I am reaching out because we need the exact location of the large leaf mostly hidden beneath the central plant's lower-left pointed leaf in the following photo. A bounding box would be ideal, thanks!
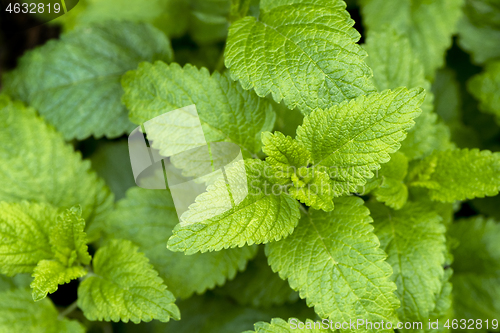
[106,187,256,298]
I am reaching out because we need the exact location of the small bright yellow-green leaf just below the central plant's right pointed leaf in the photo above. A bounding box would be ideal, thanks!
[373,152,408,209]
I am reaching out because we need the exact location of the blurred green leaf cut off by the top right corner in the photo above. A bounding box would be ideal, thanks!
[457,0,500,64]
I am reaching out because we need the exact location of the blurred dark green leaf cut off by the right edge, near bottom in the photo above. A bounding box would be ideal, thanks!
[449,216,500,332]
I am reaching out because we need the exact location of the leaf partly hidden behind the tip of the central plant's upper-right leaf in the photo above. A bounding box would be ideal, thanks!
[365,29,450,159]
